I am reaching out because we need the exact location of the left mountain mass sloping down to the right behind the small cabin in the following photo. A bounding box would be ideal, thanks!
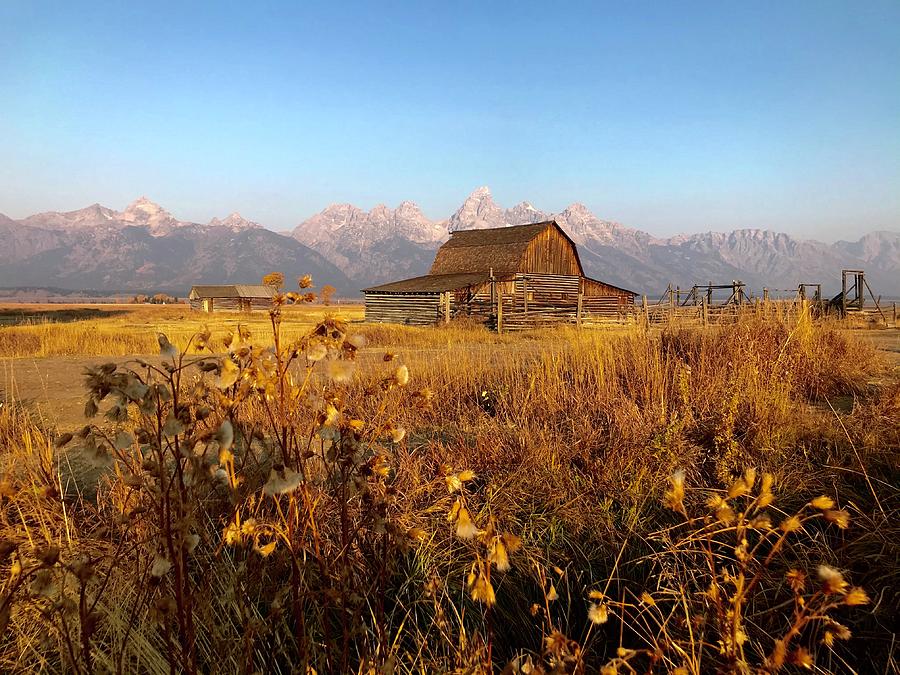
[0,197,355,294]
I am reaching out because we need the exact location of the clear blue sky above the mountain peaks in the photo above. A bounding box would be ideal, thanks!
[0,0,900,240]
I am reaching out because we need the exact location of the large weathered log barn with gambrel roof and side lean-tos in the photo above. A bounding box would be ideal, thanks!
[363,221,635,330]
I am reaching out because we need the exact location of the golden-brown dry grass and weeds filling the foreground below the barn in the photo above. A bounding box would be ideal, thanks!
[0,297,900,673]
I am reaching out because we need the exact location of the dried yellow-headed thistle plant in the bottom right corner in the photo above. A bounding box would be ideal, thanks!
[591,468,868,673]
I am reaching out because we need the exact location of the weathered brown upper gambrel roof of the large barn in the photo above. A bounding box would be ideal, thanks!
[430,220,583,276]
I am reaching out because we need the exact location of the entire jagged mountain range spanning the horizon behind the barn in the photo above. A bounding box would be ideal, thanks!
[0,187,900,296]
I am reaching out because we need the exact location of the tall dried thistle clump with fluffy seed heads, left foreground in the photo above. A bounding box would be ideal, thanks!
[27,277,429,673]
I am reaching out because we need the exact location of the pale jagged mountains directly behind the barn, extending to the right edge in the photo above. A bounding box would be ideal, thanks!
[293,187,900,296]
